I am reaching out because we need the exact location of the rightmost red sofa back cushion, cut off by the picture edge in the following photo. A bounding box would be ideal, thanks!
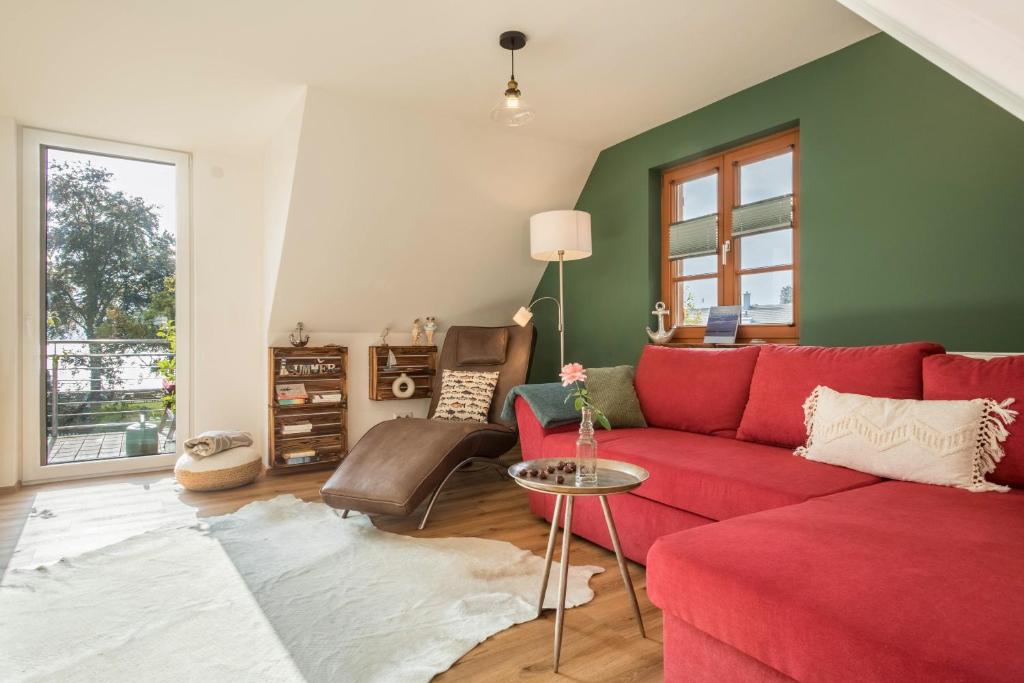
[924,354,1024,487]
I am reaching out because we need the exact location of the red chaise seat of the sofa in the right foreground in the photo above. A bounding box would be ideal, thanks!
[647,481,1024,682]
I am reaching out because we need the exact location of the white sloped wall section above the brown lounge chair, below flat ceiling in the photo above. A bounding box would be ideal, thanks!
[268,88,596,337]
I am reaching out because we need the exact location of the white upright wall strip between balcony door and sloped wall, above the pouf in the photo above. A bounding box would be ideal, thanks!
[190,152,267,456]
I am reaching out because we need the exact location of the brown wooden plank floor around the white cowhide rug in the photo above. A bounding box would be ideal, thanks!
[0,450,662,681]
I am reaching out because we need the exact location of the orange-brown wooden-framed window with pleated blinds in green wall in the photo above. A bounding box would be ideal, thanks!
[662,130,800,343]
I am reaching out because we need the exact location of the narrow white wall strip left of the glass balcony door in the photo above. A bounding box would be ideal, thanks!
[0,117,22,488]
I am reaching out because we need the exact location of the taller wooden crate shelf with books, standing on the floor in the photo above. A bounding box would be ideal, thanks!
[267,346,348,474]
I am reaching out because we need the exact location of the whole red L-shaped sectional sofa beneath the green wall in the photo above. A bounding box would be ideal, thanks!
[516,343,1024,681]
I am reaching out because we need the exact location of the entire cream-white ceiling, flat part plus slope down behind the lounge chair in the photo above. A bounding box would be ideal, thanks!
[0,0,876,335]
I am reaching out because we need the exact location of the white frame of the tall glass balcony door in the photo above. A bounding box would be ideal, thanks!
[22,128,193,483]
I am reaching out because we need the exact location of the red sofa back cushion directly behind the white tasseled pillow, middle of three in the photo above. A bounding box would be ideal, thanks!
[736,342,944,449]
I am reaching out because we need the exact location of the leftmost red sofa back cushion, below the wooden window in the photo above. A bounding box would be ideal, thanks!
[635,345,761,436]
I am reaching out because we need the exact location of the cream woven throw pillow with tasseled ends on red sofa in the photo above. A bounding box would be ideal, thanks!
[796,386,1017,492]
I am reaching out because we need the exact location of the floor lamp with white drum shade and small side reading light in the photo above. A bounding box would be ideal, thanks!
[512,210,594,367]
